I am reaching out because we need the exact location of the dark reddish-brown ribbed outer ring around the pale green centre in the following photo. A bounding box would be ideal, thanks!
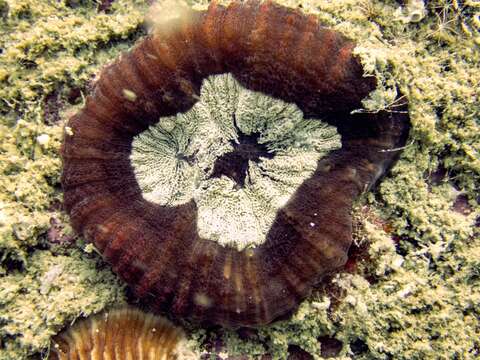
[62,1,409,327]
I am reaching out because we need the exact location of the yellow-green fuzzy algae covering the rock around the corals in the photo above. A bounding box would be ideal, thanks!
[0,0,480,359]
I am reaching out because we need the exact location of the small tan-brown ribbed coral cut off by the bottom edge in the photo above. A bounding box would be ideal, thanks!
[49,307,190,360]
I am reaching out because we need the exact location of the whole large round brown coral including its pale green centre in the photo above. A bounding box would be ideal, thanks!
[62,1,409,326]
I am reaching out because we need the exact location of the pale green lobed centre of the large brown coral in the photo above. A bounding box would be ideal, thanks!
[130,74,341,250]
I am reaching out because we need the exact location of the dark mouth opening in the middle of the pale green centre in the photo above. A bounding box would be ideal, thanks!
[210,117,275,188]
